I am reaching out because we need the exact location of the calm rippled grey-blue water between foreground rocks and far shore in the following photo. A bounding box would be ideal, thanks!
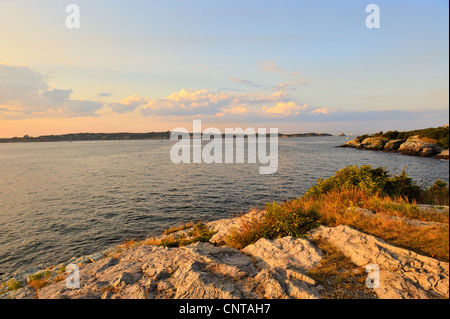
[0,137,449,273]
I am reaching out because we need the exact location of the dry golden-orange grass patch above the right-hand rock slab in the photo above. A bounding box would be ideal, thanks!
[299,189,449,261]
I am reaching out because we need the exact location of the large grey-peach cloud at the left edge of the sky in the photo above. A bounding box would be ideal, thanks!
[0,62,103,119]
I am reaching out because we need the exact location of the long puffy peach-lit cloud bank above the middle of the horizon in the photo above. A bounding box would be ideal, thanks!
[137,89,342,122]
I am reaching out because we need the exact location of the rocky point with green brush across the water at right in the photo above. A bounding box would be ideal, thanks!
[339,135,449,160]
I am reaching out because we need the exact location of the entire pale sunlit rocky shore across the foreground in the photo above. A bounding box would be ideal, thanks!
[0,206,449,299]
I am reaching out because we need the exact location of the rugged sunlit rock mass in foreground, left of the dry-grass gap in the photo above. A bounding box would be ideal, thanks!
[38,242,320,299]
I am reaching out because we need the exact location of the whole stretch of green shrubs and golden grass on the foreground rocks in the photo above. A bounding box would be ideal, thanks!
[226,166,449,261]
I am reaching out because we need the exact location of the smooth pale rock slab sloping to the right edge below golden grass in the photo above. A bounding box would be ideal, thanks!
[309,225,449,299]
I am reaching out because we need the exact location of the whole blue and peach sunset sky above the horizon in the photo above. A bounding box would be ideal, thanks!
[0,0,449,137]
